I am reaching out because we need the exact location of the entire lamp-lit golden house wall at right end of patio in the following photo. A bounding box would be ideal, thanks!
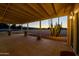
[67,13,79,54]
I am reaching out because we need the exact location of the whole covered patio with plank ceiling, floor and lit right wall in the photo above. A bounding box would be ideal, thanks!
[0,3,79,56]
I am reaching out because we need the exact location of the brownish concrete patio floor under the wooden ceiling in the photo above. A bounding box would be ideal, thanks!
[0,34,72,56]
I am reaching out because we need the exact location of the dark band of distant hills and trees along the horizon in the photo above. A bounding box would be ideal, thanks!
[0,23,67,30]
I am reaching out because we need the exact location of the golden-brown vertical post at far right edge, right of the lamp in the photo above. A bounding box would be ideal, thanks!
[73,13,79,54]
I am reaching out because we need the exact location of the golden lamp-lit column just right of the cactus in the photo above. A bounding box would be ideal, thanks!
[67,15,73,47]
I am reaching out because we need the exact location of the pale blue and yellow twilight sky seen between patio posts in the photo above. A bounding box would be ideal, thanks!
[23,16,67,28]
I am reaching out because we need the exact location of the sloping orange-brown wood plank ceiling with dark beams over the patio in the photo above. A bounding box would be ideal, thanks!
[0,3,76,24]
